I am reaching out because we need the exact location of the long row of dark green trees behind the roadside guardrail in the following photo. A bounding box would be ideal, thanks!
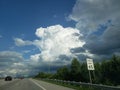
[35,55,120,85]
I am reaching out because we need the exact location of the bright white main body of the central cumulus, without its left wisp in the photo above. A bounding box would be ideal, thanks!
[32,25,85,61]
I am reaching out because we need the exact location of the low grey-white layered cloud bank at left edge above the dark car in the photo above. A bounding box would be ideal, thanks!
[0,51,27,77]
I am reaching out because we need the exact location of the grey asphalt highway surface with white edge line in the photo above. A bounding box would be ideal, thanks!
[0,79,73,90]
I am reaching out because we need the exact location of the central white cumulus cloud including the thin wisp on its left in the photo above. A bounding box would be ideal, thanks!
[14,25,85,62]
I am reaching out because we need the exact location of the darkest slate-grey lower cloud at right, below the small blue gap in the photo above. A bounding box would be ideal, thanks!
[84,26,120,55]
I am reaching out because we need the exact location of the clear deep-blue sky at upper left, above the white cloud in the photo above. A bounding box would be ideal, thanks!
[0,0,75,50]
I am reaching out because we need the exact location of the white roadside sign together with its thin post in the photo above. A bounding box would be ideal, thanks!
[86,58,95,83]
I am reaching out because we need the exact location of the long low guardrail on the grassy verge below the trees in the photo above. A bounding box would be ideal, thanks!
[40,79,120,90]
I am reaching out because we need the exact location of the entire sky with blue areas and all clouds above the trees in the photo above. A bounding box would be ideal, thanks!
[0,0,120,77]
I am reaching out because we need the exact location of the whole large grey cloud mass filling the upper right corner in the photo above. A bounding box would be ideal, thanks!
[69,0,120,58]
